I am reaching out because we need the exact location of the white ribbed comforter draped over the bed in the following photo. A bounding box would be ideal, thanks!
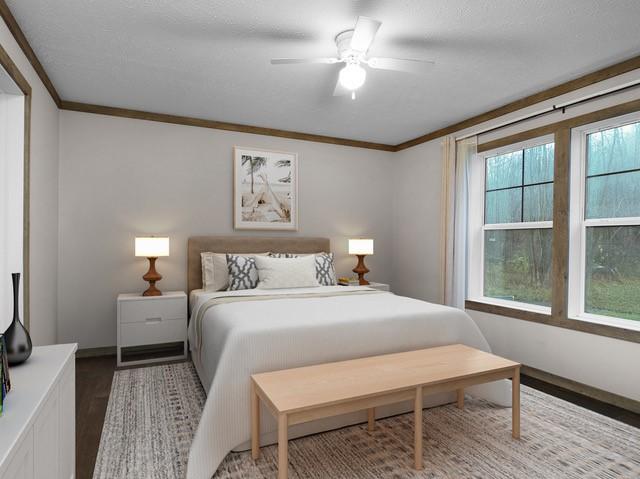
[187,286,510,479]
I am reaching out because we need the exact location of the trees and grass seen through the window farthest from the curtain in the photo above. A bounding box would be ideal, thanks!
[584,123,640,321]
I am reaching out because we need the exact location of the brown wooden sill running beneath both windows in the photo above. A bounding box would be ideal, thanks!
[465,300,640,343]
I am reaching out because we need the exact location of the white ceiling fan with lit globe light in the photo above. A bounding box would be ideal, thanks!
[271,17,434,100]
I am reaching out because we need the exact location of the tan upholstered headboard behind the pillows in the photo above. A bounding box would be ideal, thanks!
[187,236,331,293]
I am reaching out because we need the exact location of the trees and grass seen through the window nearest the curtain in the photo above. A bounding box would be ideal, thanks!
[484,143,554,306]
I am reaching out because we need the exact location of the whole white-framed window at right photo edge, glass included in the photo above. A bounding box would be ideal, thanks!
[569,114,640,328]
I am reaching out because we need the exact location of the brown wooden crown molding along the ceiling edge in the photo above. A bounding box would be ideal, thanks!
[0,0,640,152]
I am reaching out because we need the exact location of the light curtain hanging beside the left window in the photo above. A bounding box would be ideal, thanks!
[442,136,478,309]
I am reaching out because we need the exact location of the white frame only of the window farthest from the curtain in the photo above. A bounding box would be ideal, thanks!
[567,112,640,331]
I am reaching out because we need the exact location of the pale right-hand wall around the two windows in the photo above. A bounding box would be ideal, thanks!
[392,77,640,400]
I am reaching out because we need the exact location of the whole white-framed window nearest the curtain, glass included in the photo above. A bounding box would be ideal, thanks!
[469,137,554,312]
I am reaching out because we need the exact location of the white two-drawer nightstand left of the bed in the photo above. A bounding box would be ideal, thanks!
[117,291,187,367]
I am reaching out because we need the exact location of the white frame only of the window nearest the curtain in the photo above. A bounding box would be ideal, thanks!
[467,134,555,315]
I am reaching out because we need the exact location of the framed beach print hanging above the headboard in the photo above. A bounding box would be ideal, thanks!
[233,147,298,230]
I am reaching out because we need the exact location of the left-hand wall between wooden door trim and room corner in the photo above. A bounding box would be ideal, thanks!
[0,16,58,345]
